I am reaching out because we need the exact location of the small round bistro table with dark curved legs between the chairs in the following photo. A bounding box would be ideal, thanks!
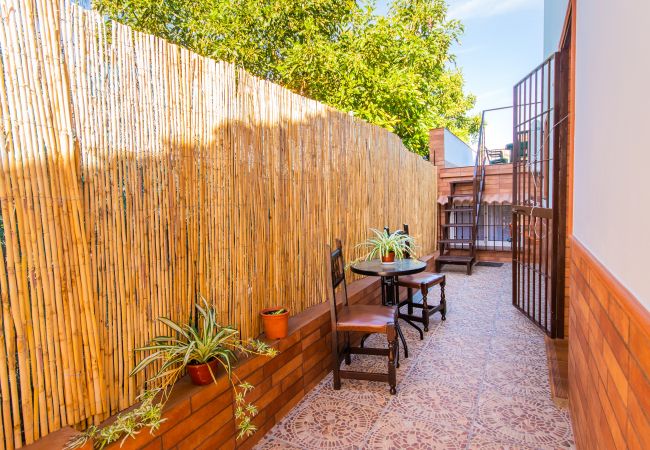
[350,259,427,358]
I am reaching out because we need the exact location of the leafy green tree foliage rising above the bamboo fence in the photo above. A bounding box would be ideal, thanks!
[94,0,479,155]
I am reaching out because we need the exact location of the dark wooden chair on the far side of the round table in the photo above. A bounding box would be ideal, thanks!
[397,224,447,331]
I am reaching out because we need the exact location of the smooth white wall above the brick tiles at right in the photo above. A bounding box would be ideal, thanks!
[574,0,650,309]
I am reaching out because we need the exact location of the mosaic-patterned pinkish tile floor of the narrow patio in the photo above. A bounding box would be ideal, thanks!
[256,264,574,449]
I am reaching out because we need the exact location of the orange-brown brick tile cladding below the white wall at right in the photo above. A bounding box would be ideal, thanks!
[569,238,650,449]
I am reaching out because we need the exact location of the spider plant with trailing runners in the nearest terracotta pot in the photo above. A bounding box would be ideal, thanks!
[66,297,278,449]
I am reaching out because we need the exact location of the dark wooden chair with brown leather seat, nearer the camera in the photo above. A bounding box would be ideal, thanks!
[327,239,398,394]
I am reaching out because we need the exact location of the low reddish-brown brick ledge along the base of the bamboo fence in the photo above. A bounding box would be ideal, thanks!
[26,256,434,450]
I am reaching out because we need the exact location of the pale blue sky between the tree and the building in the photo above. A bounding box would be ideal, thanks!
[377,0,544,148]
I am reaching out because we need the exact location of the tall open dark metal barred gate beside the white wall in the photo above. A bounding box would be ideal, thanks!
[512,52,568,338]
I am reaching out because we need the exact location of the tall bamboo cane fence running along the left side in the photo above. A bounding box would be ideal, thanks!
[0,0,437,449]
